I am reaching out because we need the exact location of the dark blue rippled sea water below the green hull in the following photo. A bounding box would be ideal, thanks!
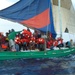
[0,55,75,75]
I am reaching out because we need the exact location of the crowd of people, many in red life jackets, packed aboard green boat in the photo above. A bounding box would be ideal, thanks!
[0,28,73,51]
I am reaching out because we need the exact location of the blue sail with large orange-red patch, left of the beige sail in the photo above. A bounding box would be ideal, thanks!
[0,0,56,37]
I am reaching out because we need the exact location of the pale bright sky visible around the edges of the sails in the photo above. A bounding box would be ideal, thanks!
[0,0,75,33]
